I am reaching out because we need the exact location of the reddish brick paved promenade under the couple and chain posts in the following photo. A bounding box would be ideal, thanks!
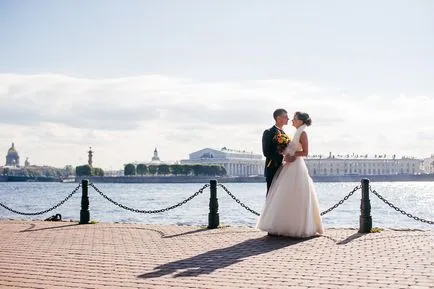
[0,220,434,288]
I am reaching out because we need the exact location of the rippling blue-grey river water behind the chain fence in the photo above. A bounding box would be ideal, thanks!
[0,182,434,230]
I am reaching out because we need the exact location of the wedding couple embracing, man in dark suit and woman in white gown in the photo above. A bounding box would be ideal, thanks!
[256,108,324,238]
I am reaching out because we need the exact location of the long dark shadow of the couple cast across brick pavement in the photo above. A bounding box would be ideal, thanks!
[138,236,311,278]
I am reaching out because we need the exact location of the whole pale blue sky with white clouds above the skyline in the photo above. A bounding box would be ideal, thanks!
[0,0,434,170]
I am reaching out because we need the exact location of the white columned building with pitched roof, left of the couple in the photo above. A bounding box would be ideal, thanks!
[180,147,264,177]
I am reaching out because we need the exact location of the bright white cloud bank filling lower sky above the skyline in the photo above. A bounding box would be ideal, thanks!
[0,74,434,168]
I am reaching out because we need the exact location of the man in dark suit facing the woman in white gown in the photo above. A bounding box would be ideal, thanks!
[262,108,289,195]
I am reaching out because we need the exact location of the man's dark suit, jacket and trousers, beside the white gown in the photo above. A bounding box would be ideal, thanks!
[262,126,285,193]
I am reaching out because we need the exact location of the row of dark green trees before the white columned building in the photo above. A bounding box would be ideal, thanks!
[124,164,226,176]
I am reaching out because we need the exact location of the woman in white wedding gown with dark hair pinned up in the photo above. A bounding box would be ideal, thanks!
[256,112,324,238]
